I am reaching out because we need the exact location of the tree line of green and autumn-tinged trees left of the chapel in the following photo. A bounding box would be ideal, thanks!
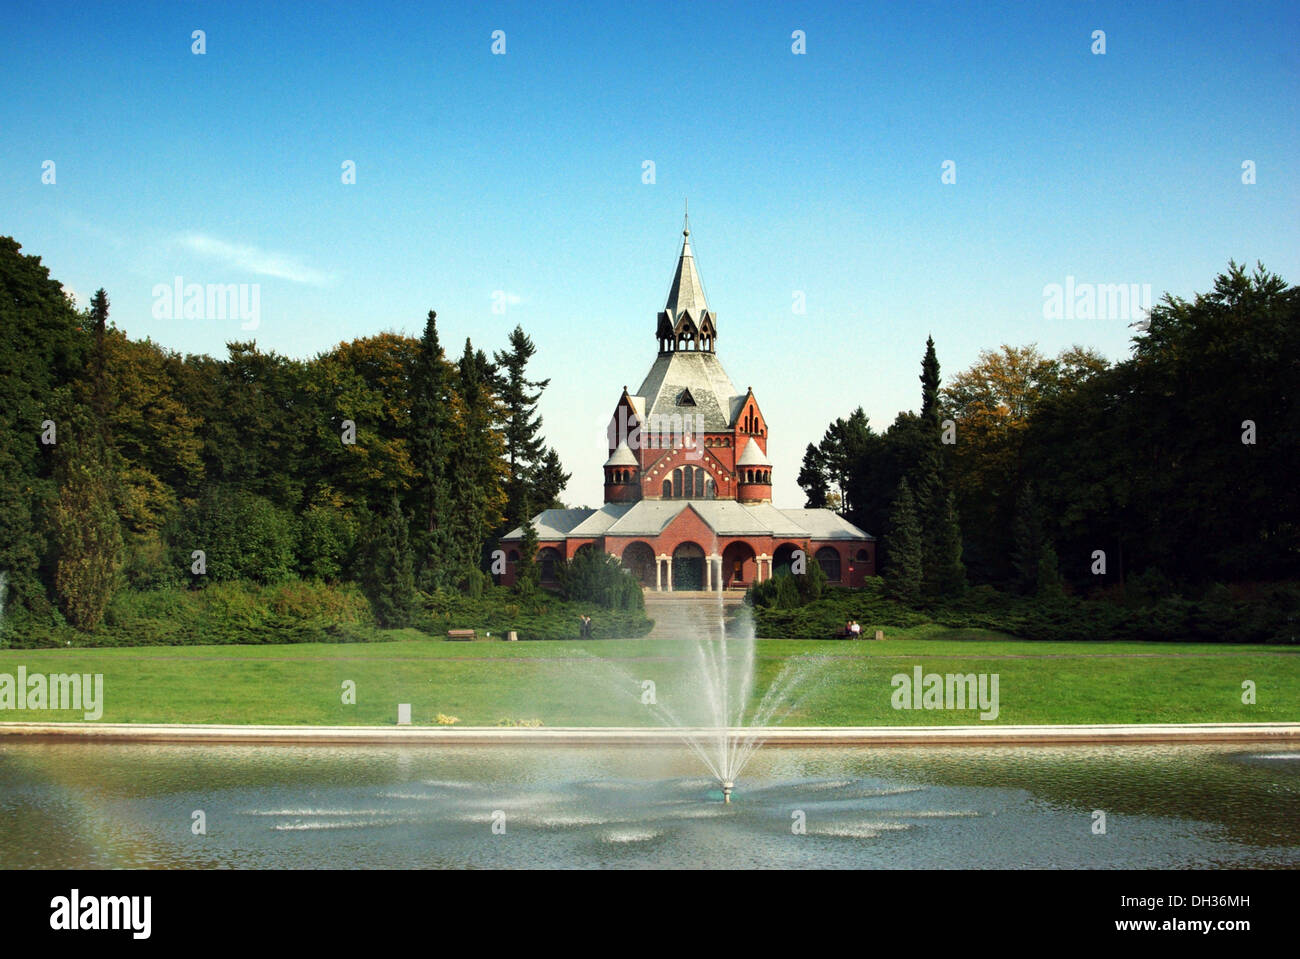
[0,237,569,629]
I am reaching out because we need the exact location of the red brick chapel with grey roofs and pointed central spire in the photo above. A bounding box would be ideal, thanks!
[499,222,876,591]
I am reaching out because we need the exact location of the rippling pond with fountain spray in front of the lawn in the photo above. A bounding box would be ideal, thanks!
[0,742,1300,869]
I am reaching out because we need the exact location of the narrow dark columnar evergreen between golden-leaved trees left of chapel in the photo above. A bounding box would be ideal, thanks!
[410,309,455,587]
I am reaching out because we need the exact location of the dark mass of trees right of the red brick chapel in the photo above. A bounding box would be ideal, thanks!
[798,262,1300,598]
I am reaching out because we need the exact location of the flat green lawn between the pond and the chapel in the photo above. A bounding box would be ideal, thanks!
[0,625,1300,726]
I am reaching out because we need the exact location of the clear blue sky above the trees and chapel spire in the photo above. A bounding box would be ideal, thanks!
[0,1,1300,505]
